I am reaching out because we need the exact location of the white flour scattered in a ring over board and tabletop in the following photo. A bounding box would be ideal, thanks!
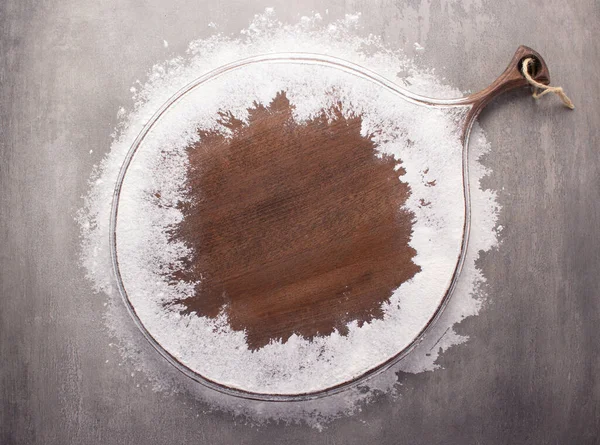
[79,10,498,427]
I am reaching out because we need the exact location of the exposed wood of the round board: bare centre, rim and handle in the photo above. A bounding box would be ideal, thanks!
[110,46,549,400]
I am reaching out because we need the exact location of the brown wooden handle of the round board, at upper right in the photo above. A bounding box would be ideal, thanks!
[465,46,550,112]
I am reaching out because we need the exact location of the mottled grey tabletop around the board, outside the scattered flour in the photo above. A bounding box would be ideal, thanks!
[0,0,600,445]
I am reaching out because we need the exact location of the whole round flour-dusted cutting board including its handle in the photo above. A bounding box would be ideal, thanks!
[111,47,547,400]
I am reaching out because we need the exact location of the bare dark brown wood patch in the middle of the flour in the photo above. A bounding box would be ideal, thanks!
[172,92,420,349]
